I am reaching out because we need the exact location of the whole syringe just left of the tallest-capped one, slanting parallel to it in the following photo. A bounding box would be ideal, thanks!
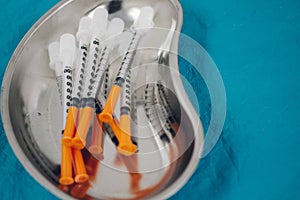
[62,17,91,146]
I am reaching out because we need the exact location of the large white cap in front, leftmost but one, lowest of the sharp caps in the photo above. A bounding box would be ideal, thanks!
[60,33,76,66]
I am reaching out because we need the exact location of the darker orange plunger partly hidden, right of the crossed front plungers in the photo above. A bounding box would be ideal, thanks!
[89,116,104,155]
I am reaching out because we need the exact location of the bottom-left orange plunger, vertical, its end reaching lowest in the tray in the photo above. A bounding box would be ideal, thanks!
[59,145,74,185]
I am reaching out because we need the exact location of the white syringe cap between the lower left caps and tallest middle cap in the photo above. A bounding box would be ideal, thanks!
[76,16,92,43]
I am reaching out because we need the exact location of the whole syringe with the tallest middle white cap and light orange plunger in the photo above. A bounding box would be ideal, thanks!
[72,8,108,149]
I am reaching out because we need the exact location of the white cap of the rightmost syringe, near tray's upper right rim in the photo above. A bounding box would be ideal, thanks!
[134,6,154,28]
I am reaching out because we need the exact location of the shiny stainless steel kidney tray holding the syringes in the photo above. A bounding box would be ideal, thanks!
[1,0,203,199]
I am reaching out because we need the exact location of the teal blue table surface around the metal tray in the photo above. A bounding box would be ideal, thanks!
[0,0,300,200]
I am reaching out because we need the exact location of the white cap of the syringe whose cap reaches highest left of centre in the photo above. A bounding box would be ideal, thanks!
[91,8,108,38]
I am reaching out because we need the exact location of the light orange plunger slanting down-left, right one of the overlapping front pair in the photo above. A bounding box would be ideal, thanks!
[72,107,94,149]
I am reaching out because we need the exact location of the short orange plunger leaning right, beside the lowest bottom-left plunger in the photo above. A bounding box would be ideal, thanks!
[72,149,89,183]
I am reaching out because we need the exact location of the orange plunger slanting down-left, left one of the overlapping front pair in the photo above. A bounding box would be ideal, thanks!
[61,106,79,146]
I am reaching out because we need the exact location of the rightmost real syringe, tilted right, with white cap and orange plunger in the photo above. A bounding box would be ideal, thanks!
[98,7,154,123]
